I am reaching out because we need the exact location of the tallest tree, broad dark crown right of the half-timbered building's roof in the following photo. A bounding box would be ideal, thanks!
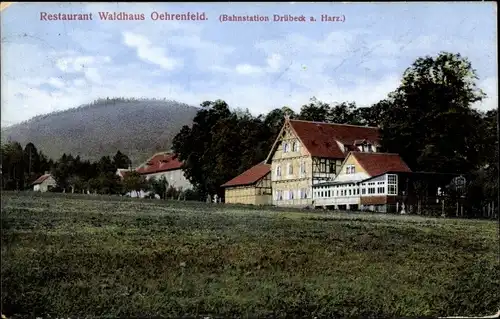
[381,52,484,173]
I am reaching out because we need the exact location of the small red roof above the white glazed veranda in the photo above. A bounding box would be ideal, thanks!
[351,152,411,176]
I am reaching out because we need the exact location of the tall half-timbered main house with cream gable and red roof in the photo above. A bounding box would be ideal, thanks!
[266,118,380,207]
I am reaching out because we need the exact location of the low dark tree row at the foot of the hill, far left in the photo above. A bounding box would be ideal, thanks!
[1,142,201,199]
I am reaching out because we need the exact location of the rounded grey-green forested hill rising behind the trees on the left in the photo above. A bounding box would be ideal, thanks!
[1,98,198,165]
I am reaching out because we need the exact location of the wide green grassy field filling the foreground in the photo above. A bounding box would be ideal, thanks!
[1,193,500,318]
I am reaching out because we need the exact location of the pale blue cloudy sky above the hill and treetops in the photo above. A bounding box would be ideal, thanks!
[1,2,498,127]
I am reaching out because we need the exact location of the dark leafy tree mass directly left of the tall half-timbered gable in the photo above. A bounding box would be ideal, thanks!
[173,100,274,196]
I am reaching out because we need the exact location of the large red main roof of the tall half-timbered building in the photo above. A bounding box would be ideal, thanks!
[290,120,380,158]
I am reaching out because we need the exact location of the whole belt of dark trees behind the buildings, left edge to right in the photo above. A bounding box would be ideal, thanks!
[2,52,498,215]
